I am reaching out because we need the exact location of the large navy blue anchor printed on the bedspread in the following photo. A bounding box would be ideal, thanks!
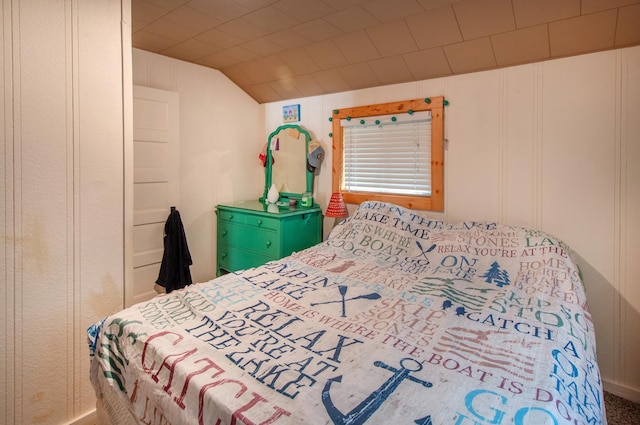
[322,357,433,425]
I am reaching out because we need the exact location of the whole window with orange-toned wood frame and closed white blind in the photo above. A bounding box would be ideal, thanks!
[332,97,444,211]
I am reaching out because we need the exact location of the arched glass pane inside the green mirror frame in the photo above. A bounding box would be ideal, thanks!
[270,127,307,193]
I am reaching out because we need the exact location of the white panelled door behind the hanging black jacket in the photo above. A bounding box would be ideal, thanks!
[125,86,180,306]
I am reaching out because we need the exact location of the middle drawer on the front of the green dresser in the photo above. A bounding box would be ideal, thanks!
[218,222,280,258]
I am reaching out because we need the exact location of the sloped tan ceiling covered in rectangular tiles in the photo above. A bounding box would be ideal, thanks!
[132,0,640,103]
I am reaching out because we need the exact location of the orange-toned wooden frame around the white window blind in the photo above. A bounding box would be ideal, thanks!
[331,96,444,211]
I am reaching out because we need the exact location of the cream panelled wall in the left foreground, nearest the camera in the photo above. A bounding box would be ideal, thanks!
[0,0,130,424]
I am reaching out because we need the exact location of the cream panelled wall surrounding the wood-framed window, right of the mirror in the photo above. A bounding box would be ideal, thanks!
[265,47,640,401]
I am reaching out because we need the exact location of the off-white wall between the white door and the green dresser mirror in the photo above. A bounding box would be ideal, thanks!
[133,49,268,286]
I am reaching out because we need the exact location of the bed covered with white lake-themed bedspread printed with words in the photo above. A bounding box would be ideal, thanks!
[88,202,606,425]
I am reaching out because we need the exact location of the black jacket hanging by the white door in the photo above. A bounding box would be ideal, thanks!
[156,207,193,293]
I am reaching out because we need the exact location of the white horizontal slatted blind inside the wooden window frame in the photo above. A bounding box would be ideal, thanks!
[340,111,431,196]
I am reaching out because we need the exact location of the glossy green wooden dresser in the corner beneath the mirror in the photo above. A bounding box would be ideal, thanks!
[216,201,322,276]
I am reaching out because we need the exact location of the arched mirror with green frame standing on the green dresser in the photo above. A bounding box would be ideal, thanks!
[260,124,314,205]
